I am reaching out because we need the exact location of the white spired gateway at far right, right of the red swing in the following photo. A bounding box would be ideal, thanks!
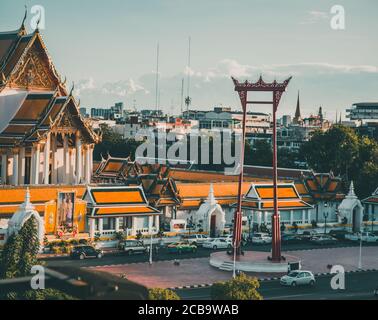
[338,181,364,232]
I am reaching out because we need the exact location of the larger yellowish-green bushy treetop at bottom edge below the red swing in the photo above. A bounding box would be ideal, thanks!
[211,273,263,300]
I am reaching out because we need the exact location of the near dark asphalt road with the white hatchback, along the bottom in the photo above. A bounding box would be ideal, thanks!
[176,272,378,300]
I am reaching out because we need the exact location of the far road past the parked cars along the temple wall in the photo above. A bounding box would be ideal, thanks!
[43,241,377,268]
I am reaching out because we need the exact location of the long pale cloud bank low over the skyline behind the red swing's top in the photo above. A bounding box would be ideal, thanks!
[73,58,378,114]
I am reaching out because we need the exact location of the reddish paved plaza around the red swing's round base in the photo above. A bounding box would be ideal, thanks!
[85,246,378,288]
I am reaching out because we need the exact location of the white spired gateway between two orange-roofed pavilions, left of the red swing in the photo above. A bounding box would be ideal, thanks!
[196,184,226,236]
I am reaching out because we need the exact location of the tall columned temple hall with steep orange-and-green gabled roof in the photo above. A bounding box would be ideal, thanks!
[0,20,100,186]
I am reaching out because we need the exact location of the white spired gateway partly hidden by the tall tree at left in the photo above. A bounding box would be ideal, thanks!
[8,188,45,244]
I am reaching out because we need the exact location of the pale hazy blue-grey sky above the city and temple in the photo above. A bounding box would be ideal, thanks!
[0,0,378,119]
